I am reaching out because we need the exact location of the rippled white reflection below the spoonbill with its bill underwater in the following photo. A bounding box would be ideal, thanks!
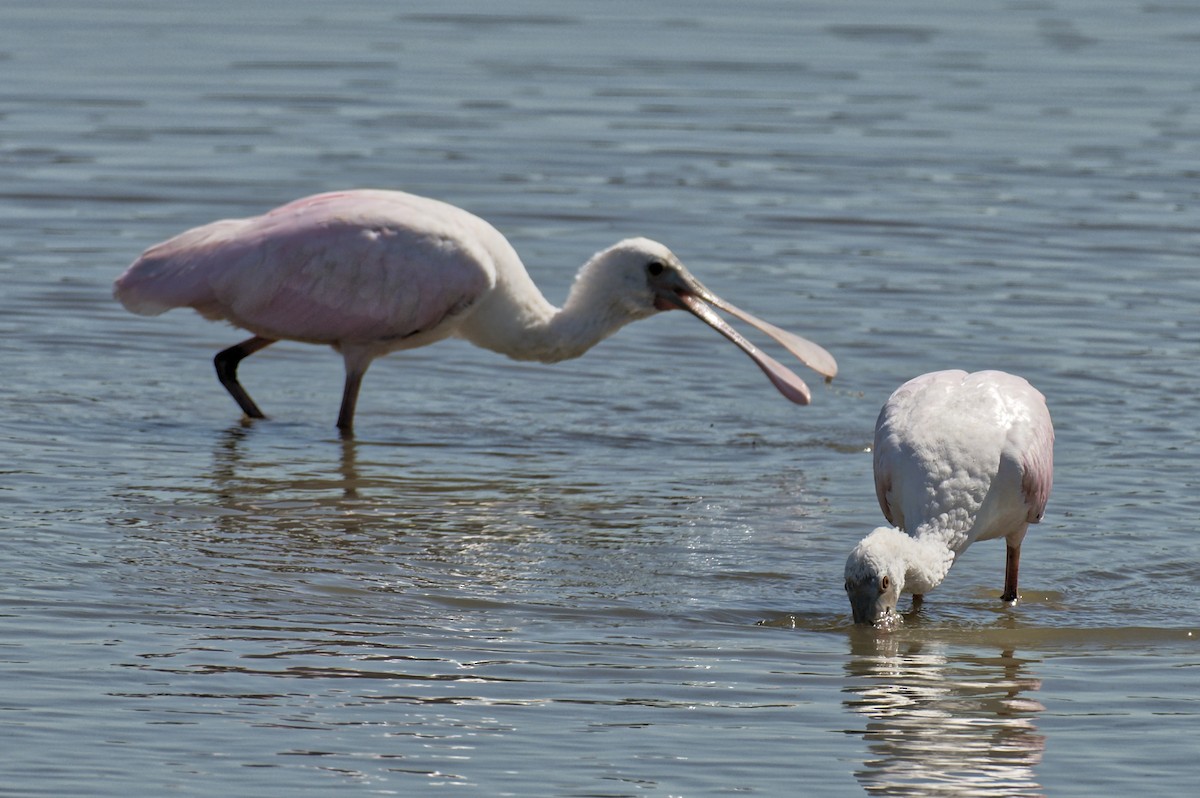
[845,630,1045,797]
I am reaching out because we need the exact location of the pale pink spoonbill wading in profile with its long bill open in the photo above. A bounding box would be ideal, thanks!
[113,190,838,432]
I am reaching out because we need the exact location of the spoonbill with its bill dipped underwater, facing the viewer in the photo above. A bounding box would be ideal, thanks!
[846,371,1054,623]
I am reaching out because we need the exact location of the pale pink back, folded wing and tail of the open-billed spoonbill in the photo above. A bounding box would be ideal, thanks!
[114,191,496,343]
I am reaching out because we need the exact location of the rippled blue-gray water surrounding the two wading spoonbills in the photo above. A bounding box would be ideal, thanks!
[0,0,1200,797]
